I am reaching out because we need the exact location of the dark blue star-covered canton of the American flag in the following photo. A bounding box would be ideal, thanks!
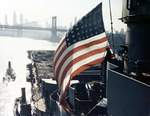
[66,3,105,46]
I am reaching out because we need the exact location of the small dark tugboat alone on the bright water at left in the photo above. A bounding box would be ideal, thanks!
[3,61,16,82]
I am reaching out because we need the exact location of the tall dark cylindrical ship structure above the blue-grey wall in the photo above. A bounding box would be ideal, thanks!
[121,0,150,76]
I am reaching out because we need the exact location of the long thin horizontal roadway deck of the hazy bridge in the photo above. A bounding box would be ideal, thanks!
[0,25,67,32]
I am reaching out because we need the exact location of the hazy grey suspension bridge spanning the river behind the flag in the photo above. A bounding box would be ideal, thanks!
[0,16,67,42]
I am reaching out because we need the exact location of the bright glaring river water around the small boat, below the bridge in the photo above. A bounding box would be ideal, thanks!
[0,37,56,116]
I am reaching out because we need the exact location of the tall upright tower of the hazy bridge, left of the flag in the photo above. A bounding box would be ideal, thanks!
[51,16,58,42]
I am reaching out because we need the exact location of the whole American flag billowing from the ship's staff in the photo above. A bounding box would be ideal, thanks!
[54,3,109,111]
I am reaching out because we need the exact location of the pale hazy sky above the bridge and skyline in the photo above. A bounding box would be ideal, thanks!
[0,0,126,31]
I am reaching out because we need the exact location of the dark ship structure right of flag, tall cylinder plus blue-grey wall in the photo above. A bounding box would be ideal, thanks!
[107,0,150,116]
